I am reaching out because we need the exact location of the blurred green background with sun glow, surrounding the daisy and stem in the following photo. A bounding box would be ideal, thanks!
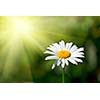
[0,16,100,83]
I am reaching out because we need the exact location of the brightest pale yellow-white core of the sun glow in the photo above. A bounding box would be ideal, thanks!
[9,17,33,35]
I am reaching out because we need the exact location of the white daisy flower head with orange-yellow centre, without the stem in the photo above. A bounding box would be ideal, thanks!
[44,40,84,69]
